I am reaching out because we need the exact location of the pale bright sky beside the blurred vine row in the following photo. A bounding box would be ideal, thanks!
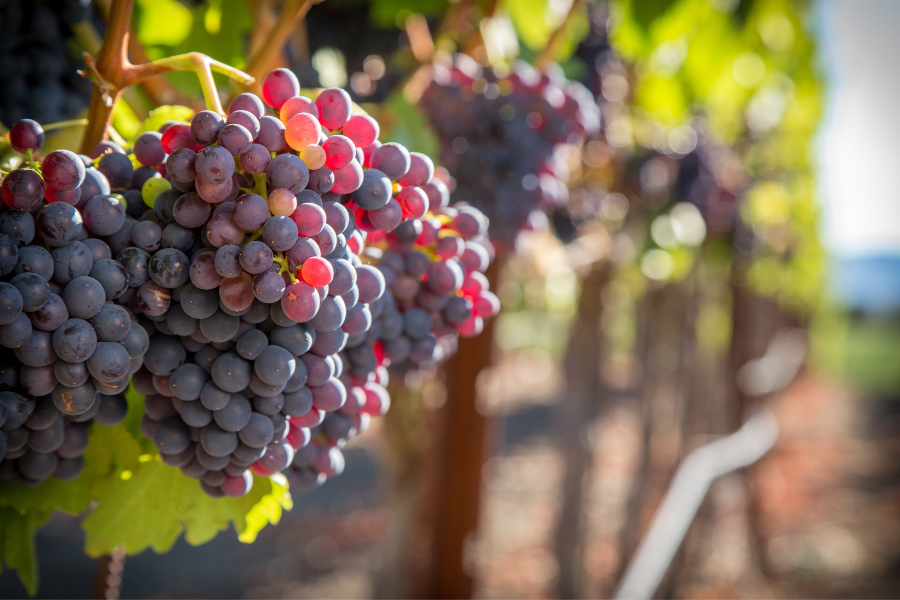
[817,0,900,258]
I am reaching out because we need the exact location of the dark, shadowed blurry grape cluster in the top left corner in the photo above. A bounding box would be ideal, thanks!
[0,0,91,126]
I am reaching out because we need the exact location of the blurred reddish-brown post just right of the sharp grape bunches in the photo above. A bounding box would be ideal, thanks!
[413,257,502,598]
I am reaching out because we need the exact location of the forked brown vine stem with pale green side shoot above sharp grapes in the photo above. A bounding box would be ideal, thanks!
[81,0,253,154]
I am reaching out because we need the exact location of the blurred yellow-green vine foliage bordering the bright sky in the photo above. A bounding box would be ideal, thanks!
[606,0,825,312]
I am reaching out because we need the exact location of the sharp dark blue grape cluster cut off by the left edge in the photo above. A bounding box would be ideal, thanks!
[0,120,134,485]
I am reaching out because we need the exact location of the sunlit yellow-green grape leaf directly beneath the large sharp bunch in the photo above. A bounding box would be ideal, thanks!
[82,456,290,556]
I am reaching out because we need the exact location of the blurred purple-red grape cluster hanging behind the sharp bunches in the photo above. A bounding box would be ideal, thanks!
[420,54,600,248]
